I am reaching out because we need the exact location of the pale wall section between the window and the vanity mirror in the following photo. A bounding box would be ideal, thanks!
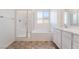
[50,9,64,31]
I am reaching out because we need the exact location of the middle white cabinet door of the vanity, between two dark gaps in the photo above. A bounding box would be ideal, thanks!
[62,31,72,49]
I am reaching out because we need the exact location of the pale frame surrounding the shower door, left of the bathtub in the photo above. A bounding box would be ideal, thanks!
[15,9,28,41]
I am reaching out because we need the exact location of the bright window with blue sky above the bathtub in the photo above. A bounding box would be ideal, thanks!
[37,11,49,24]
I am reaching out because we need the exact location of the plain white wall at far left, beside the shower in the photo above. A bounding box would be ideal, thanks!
[0,10,15,48]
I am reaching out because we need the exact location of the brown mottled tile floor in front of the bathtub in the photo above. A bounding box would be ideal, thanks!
[8,41,56,49]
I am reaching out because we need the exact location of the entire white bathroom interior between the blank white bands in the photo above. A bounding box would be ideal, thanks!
[0,9,79,49]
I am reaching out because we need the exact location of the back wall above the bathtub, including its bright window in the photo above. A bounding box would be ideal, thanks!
[33,10,50,32]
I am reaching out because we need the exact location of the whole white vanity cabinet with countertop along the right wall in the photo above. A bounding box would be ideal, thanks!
[53,28,79,49]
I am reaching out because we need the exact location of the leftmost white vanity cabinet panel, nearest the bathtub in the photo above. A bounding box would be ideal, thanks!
[53,29,61,48]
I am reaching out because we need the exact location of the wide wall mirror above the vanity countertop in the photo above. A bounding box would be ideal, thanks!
[64,10,79,26]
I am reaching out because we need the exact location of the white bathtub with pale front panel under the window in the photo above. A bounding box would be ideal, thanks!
[31,31,51,40]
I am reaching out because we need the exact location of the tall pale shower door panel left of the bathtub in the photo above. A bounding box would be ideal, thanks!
[16,10,27,37]
